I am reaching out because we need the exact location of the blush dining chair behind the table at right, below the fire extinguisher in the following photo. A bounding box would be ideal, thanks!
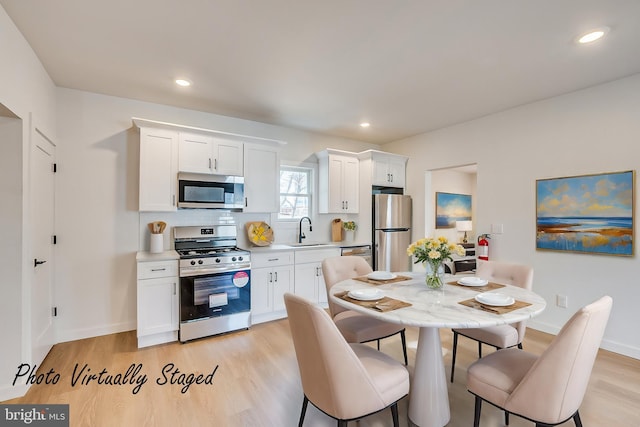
[451,261,533,382]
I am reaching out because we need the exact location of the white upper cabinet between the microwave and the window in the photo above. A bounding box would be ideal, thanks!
[243,143,280,212]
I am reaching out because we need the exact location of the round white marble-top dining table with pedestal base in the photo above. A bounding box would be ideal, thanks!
[330,272,546,427]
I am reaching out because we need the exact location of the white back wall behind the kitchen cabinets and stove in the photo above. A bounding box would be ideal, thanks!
[55,88,377,341]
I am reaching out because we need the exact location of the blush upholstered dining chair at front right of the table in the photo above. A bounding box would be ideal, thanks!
[467,296,613,427]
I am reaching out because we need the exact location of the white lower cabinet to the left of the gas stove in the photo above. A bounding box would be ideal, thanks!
[137,260,179,347]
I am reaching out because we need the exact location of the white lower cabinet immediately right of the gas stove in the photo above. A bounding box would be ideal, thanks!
[251,251,294,324]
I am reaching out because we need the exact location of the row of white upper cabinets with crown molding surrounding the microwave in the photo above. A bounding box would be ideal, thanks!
[132,117,284,213]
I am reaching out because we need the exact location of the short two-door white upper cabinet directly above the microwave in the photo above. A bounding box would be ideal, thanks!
[179,132,244,176]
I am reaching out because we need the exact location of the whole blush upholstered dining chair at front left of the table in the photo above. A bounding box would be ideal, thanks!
[284,293,409,427]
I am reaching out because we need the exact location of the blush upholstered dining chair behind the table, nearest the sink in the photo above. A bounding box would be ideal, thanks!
[322,256,408,365]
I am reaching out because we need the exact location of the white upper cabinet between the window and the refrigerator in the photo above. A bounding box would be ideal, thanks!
[316,149,360,213]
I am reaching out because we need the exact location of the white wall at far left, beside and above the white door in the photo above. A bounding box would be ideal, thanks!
[0,7,55,401]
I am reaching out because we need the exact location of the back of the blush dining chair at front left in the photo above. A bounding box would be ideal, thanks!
[284,292,386,419]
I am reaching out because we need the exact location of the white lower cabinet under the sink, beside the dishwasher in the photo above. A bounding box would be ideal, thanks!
[294,248,340,307]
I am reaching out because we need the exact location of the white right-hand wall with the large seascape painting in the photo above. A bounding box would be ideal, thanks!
[383,75,640,358]
